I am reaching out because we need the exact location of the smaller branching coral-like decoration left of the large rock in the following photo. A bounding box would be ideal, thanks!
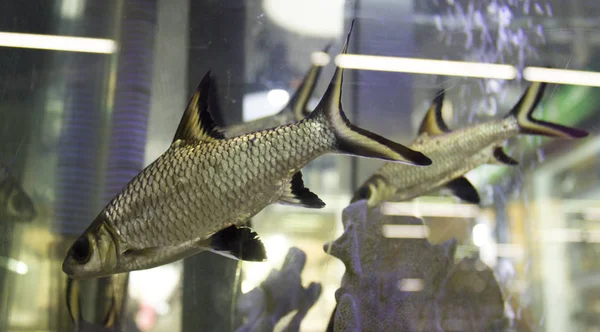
[236,247,321,332]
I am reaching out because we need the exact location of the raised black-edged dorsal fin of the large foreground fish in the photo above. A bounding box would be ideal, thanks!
[173,71,225,143]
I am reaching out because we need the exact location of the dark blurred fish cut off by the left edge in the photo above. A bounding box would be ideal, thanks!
[0,166,37,222]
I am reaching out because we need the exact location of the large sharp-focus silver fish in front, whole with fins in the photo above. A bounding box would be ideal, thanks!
[63,22,431,278]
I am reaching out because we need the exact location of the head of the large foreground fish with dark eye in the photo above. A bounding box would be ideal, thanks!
[62,213,119,279]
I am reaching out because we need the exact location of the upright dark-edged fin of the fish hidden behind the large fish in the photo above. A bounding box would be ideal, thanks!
[282,44,331,121]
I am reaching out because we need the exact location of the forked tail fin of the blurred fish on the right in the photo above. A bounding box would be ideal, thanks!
[506,82,588,138]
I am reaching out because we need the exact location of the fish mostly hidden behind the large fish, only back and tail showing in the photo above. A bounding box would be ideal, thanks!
[224,45,331,137]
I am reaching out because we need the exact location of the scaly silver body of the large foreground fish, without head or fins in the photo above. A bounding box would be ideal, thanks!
[98,119,335,272]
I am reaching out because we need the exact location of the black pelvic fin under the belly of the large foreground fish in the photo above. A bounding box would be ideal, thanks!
[206,225,267,262]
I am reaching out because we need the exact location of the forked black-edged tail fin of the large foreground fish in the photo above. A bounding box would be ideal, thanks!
[309,21,431,166]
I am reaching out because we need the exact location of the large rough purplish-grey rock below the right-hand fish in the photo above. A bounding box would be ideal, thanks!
[324,200,508,332]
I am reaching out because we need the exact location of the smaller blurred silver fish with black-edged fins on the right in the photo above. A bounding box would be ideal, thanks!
[352,82,588,206]
